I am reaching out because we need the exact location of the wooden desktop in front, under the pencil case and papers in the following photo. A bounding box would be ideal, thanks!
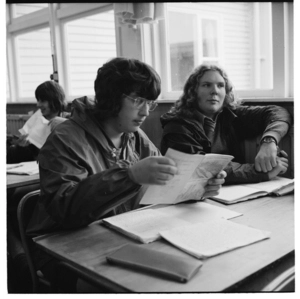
[35,195,294,293]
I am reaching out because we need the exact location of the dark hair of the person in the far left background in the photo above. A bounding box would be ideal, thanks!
[35,81,68,114]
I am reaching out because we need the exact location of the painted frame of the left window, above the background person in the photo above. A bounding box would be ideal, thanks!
[6,3,116,103]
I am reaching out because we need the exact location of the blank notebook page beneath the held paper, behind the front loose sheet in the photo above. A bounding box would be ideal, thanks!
[159,202,243,223]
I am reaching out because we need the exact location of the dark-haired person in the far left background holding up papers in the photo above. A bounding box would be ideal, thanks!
[7,81,70,164]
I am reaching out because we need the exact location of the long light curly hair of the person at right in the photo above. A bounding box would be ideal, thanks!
[170,64,237,117]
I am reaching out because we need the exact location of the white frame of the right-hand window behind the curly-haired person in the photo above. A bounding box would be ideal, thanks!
[142,2,294,102]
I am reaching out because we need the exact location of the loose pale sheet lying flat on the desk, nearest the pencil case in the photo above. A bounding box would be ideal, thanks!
[160,219,270,258]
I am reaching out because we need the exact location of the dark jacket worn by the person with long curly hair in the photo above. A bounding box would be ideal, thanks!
[160,105,291,184]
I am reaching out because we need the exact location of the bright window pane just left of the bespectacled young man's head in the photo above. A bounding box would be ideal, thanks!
[65,11,116,96]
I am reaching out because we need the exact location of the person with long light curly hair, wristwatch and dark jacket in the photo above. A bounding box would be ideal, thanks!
[161,65,291,183]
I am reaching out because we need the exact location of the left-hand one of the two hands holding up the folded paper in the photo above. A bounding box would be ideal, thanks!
[128,157,178,185]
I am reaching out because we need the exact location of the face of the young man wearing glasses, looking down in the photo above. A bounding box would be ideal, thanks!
[109,93,149,133]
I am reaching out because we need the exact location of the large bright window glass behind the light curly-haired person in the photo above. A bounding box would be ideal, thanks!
[154,2,274,99]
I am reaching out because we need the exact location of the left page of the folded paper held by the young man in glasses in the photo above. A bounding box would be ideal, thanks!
[140,148,204,204]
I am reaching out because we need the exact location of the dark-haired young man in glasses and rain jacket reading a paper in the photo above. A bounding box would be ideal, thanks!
[27,58,226,292]
